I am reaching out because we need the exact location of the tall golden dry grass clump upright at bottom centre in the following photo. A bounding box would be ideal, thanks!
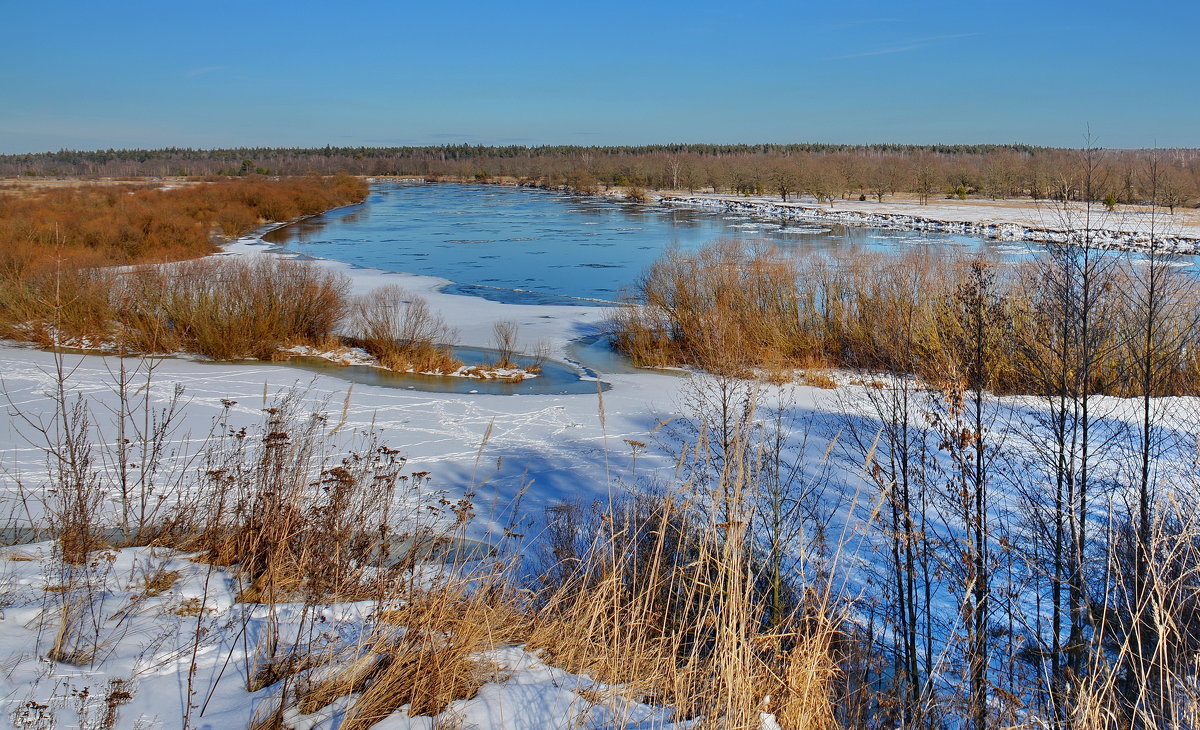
[528,485,842,730]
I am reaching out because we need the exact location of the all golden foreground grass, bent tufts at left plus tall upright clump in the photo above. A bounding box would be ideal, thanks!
[256,487,842,730]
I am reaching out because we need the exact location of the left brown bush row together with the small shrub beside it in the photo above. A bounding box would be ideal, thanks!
[0,256,477,373]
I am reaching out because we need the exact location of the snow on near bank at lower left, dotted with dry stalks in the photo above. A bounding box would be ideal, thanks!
[0,543,688,730]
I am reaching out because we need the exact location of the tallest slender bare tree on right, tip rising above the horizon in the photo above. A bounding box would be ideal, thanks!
[1020,138,1120,720]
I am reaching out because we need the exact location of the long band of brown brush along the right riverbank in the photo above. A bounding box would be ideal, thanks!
[608,241,1200,395]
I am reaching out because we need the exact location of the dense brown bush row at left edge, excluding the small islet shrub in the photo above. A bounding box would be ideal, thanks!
[0,257,349,360]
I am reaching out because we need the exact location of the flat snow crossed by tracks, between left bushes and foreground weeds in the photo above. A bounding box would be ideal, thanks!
[0,338,685,533]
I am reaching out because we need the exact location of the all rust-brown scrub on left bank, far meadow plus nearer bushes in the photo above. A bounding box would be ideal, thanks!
[0,176,366,357]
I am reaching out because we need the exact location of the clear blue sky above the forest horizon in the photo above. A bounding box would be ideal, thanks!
[0,0,1200,152]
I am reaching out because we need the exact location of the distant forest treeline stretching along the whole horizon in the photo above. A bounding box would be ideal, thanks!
[0,144,1200,209]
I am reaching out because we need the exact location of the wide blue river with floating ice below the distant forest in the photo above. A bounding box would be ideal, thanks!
[264,183,1012,305]
